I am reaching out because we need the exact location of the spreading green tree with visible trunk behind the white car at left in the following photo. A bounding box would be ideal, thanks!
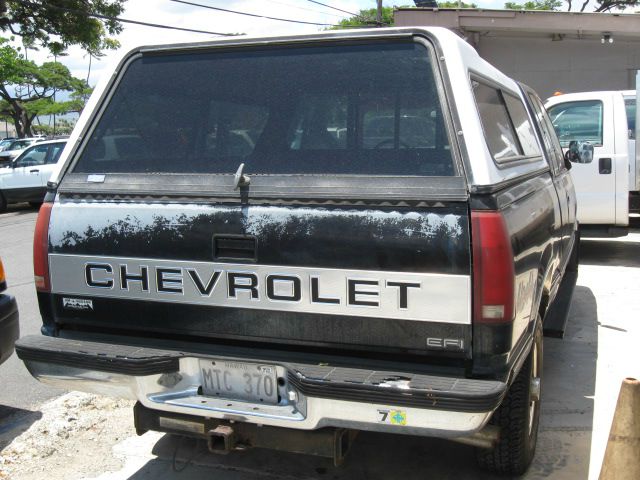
[0,38,87,137]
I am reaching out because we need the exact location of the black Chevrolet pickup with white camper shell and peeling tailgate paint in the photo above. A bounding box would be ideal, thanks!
[16,28,578,474]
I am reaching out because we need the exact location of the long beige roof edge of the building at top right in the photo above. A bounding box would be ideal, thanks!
[394,8,640,41]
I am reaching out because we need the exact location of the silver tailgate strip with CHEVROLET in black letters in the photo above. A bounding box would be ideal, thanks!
[49,254,471,325]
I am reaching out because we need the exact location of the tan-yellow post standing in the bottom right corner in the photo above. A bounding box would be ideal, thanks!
[600,378,640,480]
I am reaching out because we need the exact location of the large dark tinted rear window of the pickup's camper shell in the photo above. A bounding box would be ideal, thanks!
[74,43,454,176]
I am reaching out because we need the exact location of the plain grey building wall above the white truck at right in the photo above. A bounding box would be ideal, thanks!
[476,36,640,99]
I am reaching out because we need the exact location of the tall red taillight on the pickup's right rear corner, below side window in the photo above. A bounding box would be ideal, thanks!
[471,211,515,323]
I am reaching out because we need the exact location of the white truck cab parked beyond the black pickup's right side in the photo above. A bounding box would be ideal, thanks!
[545,90,640,236]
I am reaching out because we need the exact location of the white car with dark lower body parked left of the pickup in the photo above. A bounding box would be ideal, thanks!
[0,140,67,212]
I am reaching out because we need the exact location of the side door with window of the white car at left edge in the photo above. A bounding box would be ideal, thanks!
[3,145,49,201]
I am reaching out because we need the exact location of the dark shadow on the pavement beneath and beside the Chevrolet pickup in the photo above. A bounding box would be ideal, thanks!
[120,285,598,480]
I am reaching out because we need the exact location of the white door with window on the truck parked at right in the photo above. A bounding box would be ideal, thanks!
[547,93,626,224]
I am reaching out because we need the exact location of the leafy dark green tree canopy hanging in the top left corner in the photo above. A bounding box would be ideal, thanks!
[0,0,126,56]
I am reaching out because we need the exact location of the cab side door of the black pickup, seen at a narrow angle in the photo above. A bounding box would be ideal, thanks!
[522,85,577,258]
